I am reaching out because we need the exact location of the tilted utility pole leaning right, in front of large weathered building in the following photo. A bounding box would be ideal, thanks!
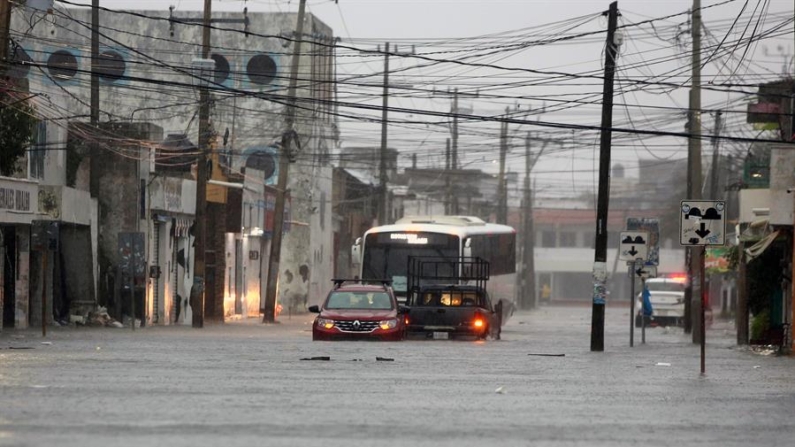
[262,0,306,323]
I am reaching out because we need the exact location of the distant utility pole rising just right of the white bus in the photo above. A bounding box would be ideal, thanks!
[522,132,540,309]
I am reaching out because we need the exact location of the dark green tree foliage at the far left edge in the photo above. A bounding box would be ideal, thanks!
[0,91,37,176]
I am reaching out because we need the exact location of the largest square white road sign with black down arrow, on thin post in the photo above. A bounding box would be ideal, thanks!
[679,200,726,245]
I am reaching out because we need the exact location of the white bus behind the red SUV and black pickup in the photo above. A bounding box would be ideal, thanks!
[352,216,516,309]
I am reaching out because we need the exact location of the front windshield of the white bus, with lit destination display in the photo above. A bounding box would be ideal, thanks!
[362,232,460,292]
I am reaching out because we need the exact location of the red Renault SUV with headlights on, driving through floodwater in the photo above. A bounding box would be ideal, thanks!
[309,280,407,341]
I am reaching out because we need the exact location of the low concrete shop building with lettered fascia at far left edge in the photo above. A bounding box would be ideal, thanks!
[0,89,98,329]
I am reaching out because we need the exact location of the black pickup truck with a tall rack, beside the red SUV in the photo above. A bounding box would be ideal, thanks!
[406,258,502,340]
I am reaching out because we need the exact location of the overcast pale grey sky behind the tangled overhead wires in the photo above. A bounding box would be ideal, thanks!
[71,0,795,195]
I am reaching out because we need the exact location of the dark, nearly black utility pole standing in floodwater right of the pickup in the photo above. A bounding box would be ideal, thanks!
[591,2,618,351]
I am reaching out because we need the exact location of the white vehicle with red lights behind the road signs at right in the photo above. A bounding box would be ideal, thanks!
[635,277,686,327]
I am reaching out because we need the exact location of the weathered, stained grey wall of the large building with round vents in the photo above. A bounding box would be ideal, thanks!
[12,8,337,315]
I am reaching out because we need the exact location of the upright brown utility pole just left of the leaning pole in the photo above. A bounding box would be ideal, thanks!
[190,0,212,328]
